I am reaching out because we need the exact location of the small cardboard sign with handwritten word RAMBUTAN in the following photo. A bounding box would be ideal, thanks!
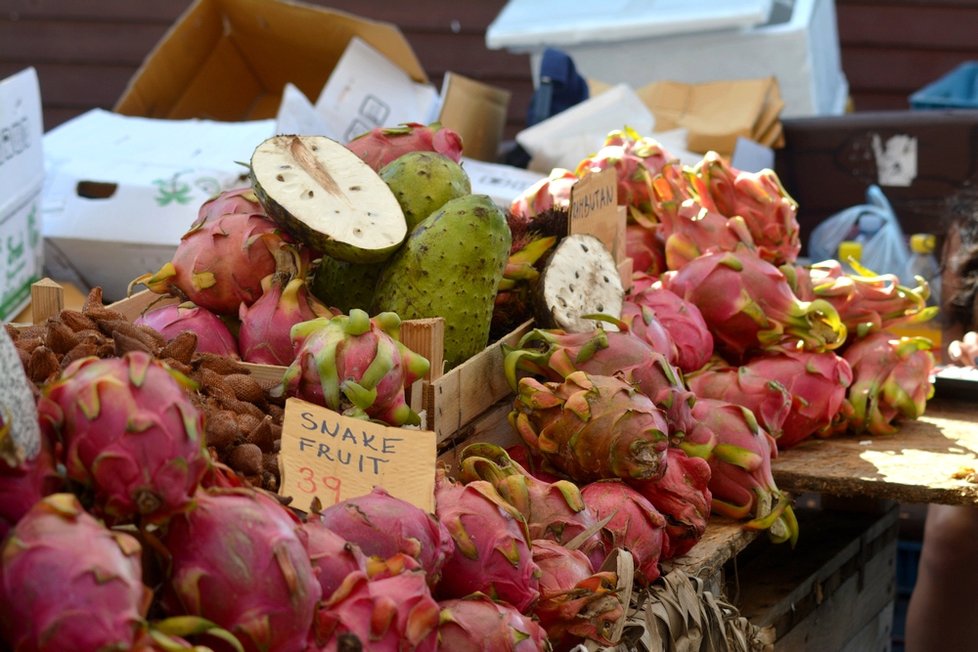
[567,168,625,261]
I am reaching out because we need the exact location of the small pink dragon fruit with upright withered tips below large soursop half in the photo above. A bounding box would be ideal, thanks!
[238,245,334,367]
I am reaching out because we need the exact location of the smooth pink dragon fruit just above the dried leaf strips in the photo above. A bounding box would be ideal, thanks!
[581,480,666,584]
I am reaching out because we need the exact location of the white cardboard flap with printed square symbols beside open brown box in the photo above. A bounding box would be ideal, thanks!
[315,36,438,142]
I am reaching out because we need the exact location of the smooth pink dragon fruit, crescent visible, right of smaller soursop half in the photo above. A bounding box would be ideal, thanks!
[623,283,713,374]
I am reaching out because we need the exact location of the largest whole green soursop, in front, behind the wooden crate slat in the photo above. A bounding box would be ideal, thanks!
[372,195,512,369]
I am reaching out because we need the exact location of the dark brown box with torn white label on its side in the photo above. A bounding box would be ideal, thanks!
[775,110,978,253]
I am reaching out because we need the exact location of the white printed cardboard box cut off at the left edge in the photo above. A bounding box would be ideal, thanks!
[0,68,44,321]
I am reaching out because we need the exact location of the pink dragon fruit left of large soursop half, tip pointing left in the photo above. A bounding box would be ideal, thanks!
[130,213,292,316]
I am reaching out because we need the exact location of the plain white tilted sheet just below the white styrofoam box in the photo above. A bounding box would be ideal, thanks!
[516,84,655,174]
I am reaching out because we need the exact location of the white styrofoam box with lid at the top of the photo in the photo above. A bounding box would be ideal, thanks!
[486,0,849,118]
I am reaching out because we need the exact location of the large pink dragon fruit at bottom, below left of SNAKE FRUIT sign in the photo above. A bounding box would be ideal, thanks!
[162,488,322,652]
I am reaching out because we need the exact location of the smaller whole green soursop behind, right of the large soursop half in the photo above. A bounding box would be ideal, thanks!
[378,152,472,232]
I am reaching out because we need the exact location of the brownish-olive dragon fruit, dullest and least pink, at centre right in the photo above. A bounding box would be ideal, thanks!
[509,371,669,482]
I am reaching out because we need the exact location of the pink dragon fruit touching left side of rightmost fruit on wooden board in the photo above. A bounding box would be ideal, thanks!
[739,349,853,450]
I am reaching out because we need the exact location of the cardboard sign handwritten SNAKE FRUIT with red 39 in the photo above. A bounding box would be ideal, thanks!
[279,398,437,513]
